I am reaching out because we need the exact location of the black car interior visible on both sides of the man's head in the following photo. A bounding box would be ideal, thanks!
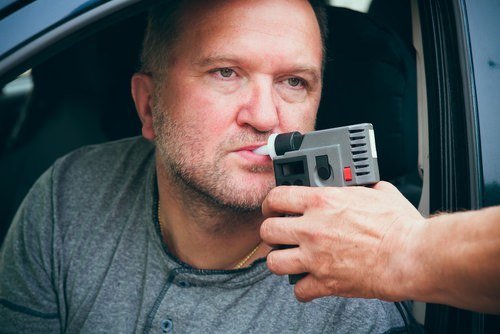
[0,0,422,247]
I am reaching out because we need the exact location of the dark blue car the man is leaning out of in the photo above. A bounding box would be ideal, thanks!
[0,0,500,333]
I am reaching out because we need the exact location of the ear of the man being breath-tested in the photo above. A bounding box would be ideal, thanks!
[131,73,156,140]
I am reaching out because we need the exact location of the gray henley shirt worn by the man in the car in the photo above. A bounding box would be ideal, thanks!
[0,138,404,333]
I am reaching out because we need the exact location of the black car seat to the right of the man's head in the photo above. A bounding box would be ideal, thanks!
[316,7,421,206]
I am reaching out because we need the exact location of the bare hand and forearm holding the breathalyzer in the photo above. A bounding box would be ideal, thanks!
[261,182,500,314]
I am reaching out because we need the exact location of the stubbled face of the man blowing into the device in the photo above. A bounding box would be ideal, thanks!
[153,0,322,210]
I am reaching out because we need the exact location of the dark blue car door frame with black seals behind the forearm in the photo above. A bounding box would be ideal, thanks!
[418,0,500,333]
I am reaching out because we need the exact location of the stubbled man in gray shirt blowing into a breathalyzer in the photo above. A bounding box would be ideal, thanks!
[0,0,410,333]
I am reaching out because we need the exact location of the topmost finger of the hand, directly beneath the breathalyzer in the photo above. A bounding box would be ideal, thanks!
[262,186,319,217]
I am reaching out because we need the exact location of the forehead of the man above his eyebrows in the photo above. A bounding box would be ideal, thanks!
[170,0,322,71]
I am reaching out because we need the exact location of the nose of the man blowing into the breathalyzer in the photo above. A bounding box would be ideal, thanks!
[237,80,279,132]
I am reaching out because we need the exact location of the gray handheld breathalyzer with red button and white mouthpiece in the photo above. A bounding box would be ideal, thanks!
[253,123,380,284]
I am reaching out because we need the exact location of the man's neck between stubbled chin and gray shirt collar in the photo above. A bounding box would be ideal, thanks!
[157,160,270,269]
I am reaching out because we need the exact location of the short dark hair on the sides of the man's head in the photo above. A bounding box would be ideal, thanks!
[139,0,328,80]
